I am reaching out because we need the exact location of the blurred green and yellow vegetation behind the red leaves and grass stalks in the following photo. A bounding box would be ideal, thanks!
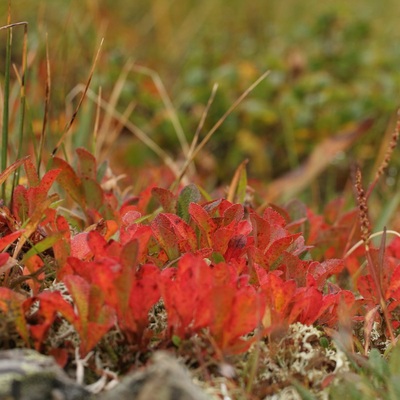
[0,0,400,209]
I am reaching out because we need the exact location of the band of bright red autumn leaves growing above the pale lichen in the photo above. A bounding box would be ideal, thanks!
[0,149,400,364]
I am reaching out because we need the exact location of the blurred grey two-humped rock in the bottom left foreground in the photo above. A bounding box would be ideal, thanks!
[0,349,214,400]
